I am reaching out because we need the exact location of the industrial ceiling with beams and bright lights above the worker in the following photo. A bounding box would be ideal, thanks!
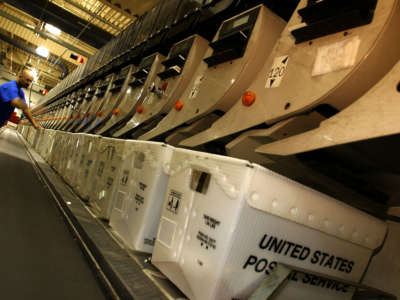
[0,0,159,88]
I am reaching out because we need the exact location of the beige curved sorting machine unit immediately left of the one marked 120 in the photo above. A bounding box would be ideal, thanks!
[139,6,284,144]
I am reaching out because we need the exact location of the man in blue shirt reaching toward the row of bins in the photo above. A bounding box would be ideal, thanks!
[0,68,42,129]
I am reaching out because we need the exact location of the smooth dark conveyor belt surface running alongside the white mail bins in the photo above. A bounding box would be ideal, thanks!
[0,129,106,300]
